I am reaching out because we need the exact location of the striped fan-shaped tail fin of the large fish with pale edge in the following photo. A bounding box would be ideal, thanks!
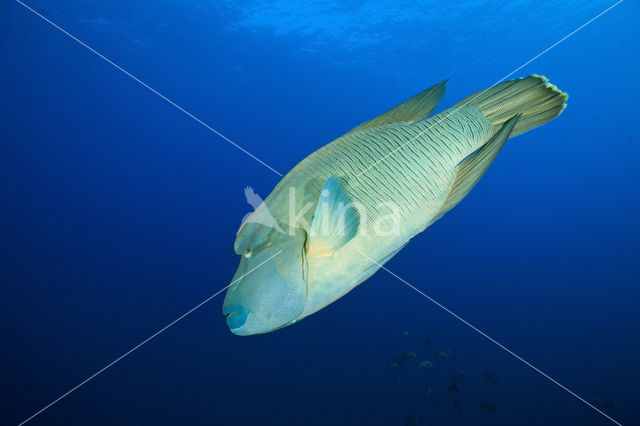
[454,74,569,137]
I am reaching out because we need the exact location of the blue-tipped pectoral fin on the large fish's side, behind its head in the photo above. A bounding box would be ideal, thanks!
[307,176,360,256]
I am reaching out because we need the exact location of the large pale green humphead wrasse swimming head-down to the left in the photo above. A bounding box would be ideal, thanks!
[222,74,568,336]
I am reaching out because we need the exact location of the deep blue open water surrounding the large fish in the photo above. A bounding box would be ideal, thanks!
[0,0,640,425]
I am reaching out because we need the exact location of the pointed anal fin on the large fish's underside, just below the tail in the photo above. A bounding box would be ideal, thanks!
[432,114,520,223]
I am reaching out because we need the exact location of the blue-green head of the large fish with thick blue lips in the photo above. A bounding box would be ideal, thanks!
[222,222,308,336]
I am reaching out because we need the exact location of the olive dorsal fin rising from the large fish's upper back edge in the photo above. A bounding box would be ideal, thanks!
[349,79,449,133]
